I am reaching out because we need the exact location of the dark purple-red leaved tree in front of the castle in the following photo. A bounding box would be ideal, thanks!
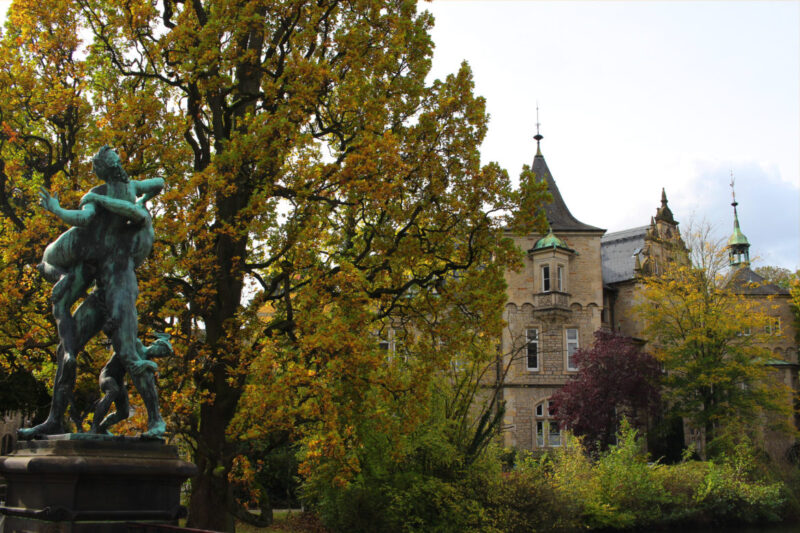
[552,331,661,450]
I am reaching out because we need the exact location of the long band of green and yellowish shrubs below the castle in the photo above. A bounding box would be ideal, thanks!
[316,416,800,533]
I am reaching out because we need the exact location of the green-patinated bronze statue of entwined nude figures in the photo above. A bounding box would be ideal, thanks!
[19,146,172,439]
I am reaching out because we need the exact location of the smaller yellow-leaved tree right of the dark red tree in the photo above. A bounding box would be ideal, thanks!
[637,238,792,454]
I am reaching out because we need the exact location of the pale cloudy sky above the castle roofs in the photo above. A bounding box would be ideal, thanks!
[0,0,800,270]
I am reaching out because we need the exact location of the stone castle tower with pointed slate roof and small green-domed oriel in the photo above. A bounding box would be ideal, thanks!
[502,124,605,450]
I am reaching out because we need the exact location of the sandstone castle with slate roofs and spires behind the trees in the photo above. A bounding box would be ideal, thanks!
[499,133,797,450]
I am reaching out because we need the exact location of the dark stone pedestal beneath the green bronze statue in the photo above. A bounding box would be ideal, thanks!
[0,434,197,533]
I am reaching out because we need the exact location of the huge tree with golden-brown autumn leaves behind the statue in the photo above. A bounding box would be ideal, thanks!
[0,0,545,529]
